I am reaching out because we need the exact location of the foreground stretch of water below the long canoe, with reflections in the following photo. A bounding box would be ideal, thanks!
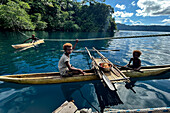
[0,79,170,113]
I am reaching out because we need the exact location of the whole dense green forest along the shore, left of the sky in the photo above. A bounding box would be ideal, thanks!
[0,0,116,32]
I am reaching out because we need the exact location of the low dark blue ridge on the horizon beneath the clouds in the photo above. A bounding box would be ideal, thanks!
[117,23,170,32]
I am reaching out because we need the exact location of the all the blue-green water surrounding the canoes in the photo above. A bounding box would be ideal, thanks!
[0,31,170,113]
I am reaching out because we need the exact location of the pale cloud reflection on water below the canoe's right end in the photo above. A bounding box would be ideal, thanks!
[112,80,170,109]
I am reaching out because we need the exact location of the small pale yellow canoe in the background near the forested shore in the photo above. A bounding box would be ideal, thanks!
[11,39,44,49]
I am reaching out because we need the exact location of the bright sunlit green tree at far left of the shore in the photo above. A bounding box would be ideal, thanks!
[0,1,35,30]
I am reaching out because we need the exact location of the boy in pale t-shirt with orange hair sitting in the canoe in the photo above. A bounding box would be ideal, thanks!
[58,39,84,76]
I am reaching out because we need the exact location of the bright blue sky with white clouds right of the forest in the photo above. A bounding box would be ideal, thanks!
[78,0,170,25]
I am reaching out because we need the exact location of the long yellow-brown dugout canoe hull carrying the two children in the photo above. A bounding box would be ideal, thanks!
[0,65,170,84]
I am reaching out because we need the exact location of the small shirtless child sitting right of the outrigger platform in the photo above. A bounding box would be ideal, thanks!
[125,50,142,70]
